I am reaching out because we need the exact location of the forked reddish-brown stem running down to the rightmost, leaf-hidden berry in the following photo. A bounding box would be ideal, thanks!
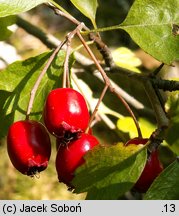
[77,32,142,138]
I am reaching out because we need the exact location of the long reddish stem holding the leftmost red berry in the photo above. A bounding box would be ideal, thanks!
[26,40,66,120]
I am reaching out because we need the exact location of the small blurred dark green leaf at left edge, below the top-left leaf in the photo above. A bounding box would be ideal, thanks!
[0,16,16,41]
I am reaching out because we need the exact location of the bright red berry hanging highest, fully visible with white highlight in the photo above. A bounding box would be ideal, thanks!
[43,88,90,138]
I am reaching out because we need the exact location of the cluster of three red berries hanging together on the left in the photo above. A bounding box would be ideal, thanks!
[7,88,99,186]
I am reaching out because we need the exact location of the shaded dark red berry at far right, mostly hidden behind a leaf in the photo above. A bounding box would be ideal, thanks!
[125,138,163,193]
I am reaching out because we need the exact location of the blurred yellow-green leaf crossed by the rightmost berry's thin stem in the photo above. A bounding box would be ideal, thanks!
[117,117,155,138]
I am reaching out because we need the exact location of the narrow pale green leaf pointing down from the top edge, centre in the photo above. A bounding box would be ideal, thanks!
[70,0,98,27]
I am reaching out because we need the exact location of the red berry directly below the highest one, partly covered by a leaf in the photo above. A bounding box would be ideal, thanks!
[56,133,99,187]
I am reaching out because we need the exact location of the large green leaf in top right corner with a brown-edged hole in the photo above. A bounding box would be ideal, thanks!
[120,0,179,64]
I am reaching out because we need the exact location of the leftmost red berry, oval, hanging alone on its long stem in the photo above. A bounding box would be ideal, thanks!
[7,120,51,176]
